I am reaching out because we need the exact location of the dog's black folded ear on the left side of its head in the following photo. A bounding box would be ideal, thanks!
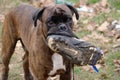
[33,7,45,27]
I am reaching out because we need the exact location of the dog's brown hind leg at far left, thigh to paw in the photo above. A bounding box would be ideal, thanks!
[1,16,17,80]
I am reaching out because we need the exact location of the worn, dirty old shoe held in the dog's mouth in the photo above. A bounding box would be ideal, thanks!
[47,35,102,65]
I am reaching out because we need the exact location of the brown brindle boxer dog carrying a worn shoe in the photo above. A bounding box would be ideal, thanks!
[2,4,79,80]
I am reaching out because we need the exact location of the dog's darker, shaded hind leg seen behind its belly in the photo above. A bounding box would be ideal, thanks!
[20,40,33,80]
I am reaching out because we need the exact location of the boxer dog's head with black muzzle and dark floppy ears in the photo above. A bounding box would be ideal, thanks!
[33,4,79,37]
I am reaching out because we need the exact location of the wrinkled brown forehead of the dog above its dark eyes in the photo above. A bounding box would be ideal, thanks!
[43,4,72,19]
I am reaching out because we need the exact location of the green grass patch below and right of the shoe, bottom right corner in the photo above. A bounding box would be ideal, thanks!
[74,50,120,80]
